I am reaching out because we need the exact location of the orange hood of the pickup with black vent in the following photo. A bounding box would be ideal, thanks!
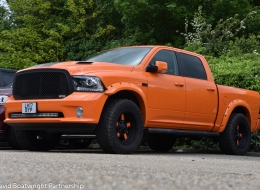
[26,61,134,75]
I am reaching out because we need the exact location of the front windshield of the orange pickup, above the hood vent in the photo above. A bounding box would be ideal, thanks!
[86,47,152,66]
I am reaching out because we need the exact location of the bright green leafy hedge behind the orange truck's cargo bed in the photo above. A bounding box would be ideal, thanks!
[208,54,260,92]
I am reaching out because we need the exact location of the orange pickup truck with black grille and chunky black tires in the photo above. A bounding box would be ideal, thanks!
[4,46,260,155]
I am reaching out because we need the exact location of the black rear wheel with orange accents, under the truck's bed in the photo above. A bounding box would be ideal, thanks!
[219,113,251,155]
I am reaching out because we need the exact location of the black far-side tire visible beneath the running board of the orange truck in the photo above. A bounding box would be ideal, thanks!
[146,133,176,152]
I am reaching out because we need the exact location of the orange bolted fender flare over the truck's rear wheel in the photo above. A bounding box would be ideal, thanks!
[218,99,252,133]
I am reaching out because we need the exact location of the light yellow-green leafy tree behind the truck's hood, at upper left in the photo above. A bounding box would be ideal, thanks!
[0,0,120,69]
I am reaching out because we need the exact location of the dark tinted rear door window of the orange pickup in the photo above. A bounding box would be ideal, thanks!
[179,53,207,80]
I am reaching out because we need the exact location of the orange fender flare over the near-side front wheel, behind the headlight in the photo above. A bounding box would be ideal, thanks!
[104,82,147,122]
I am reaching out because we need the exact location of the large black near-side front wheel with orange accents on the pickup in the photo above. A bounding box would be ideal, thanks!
[96,99,143,154]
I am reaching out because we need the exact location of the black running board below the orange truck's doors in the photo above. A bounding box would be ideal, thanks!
[146,128,219,137]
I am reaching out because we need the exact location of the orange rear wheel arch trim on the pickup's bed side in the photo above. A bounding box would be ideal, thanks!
[218,100,252,132]
